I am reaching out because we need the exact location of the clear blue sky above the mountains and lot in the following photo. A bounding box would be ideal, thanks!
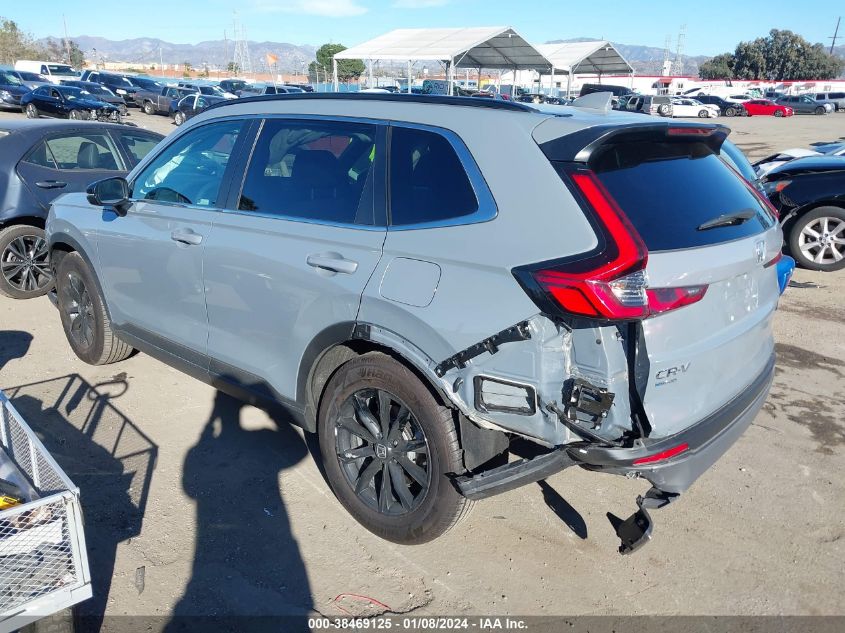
[8,0,845,55]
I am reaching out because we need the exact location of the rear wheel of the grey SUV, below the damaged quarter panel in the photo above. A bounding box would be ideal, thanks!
[318,353,472,545]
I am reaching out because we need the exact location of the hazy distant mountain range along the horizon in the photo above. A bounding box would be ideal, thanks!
[42,35,845,75]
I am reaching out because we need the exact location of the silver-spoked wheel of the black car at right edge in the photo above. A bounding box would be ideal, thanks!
[789,207,845,272]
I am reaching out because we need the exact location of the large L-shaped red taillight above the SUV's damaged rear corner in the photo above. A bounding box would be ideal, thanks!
[515,169,707,320]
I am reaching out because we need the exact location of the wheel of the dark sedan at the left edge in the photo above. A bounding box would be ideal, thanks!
[0,224,53,299]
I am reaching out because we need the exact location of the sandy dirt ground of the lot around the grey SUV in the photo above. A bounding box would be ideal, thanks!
[0,105,845,631]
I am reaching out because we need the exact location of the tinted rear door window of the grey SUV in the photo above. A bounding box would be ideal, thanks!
[238,119,378,225]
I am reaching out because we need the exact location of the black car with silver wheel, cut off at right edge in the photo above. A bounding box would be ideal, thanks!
[763,156,845,271]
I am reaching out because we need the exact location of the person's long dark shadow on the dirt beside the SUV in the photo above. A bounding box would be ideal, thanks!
[165,392,313,632]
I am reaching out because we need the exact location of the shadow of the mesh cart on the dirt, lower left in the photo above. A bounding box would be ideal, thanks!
[5,374,158,631]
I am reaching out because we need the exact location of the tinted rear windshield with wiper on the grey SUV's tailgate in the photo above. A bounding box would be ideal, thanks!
[590,141,773,251]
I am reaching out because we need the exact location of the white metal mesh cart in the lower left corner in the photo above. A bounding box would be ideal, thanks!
[0,390,92,633]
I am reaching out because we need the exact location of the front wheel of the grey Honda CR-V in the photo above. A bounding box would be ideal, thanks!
[56,253,132,365]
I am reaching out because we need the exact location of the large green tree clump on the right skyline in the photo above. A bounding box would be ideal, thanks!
[700,29,845,81]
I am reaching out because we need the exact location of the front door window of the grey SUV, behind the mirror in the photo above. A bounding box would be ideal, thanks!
[131,121,243,207]
